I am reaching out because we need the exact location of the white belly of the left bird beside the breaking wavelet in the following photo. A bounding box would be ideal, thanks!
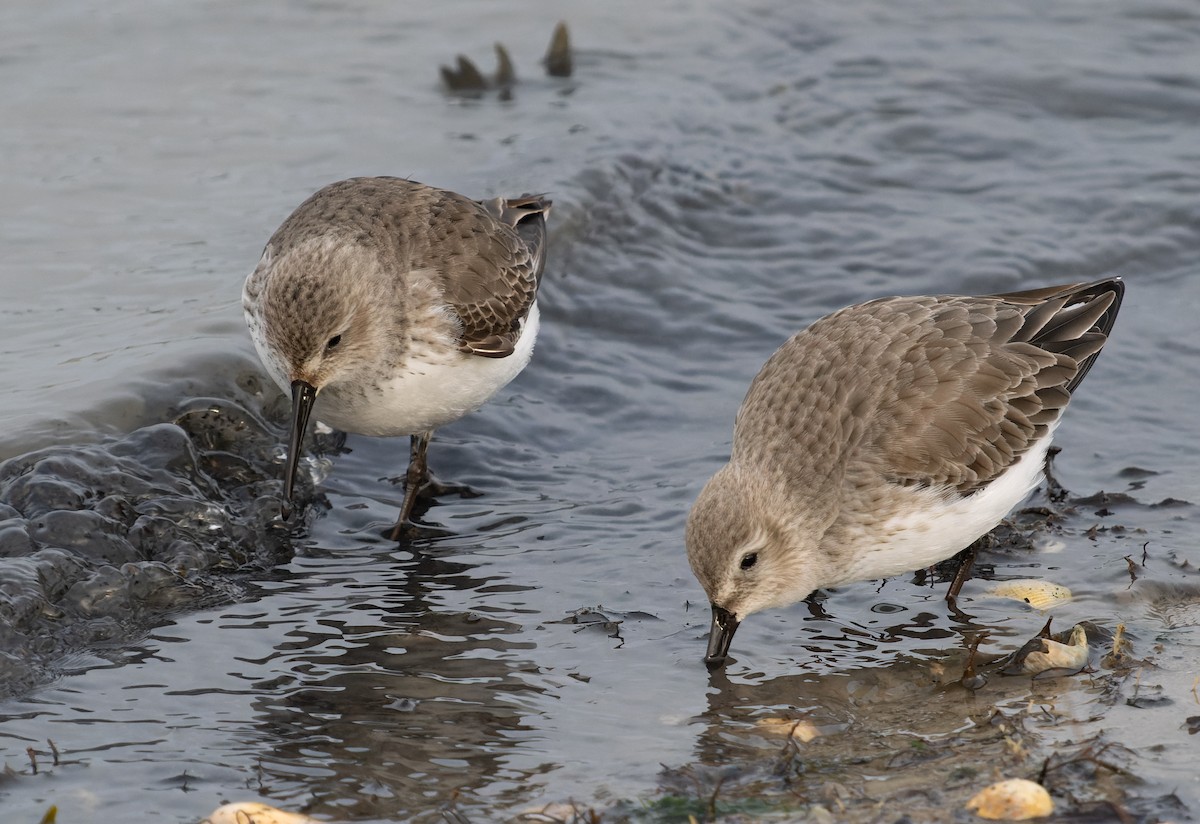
[316,302,539,438]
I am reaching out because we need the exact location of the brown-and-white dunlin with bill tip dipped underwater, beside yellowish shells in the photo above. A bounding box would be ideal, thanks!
[686,279,1124,667]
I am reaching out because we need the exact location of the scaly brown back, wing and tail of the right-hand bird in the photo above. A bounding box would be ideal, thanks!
[733,279,1124,500]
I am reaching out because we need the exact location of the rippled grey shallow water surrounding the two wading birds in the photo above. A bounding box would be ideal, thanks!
[0,0,1200,822]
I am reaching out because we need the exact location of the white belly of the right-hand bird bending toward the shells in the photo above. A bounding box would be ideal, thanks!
[840,422,1058,587]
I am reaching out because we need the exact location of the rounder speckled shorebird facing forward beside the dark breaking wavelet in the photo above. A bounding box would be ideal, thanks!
[242,178,550,540]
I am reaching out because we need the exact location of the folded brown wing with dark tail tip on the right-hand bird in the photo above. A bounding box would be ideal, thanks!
[865,279,1124,494]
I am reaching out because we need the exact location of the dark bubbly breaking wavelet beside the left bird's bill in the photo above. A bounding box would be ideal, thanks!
[0,386,311,694]
